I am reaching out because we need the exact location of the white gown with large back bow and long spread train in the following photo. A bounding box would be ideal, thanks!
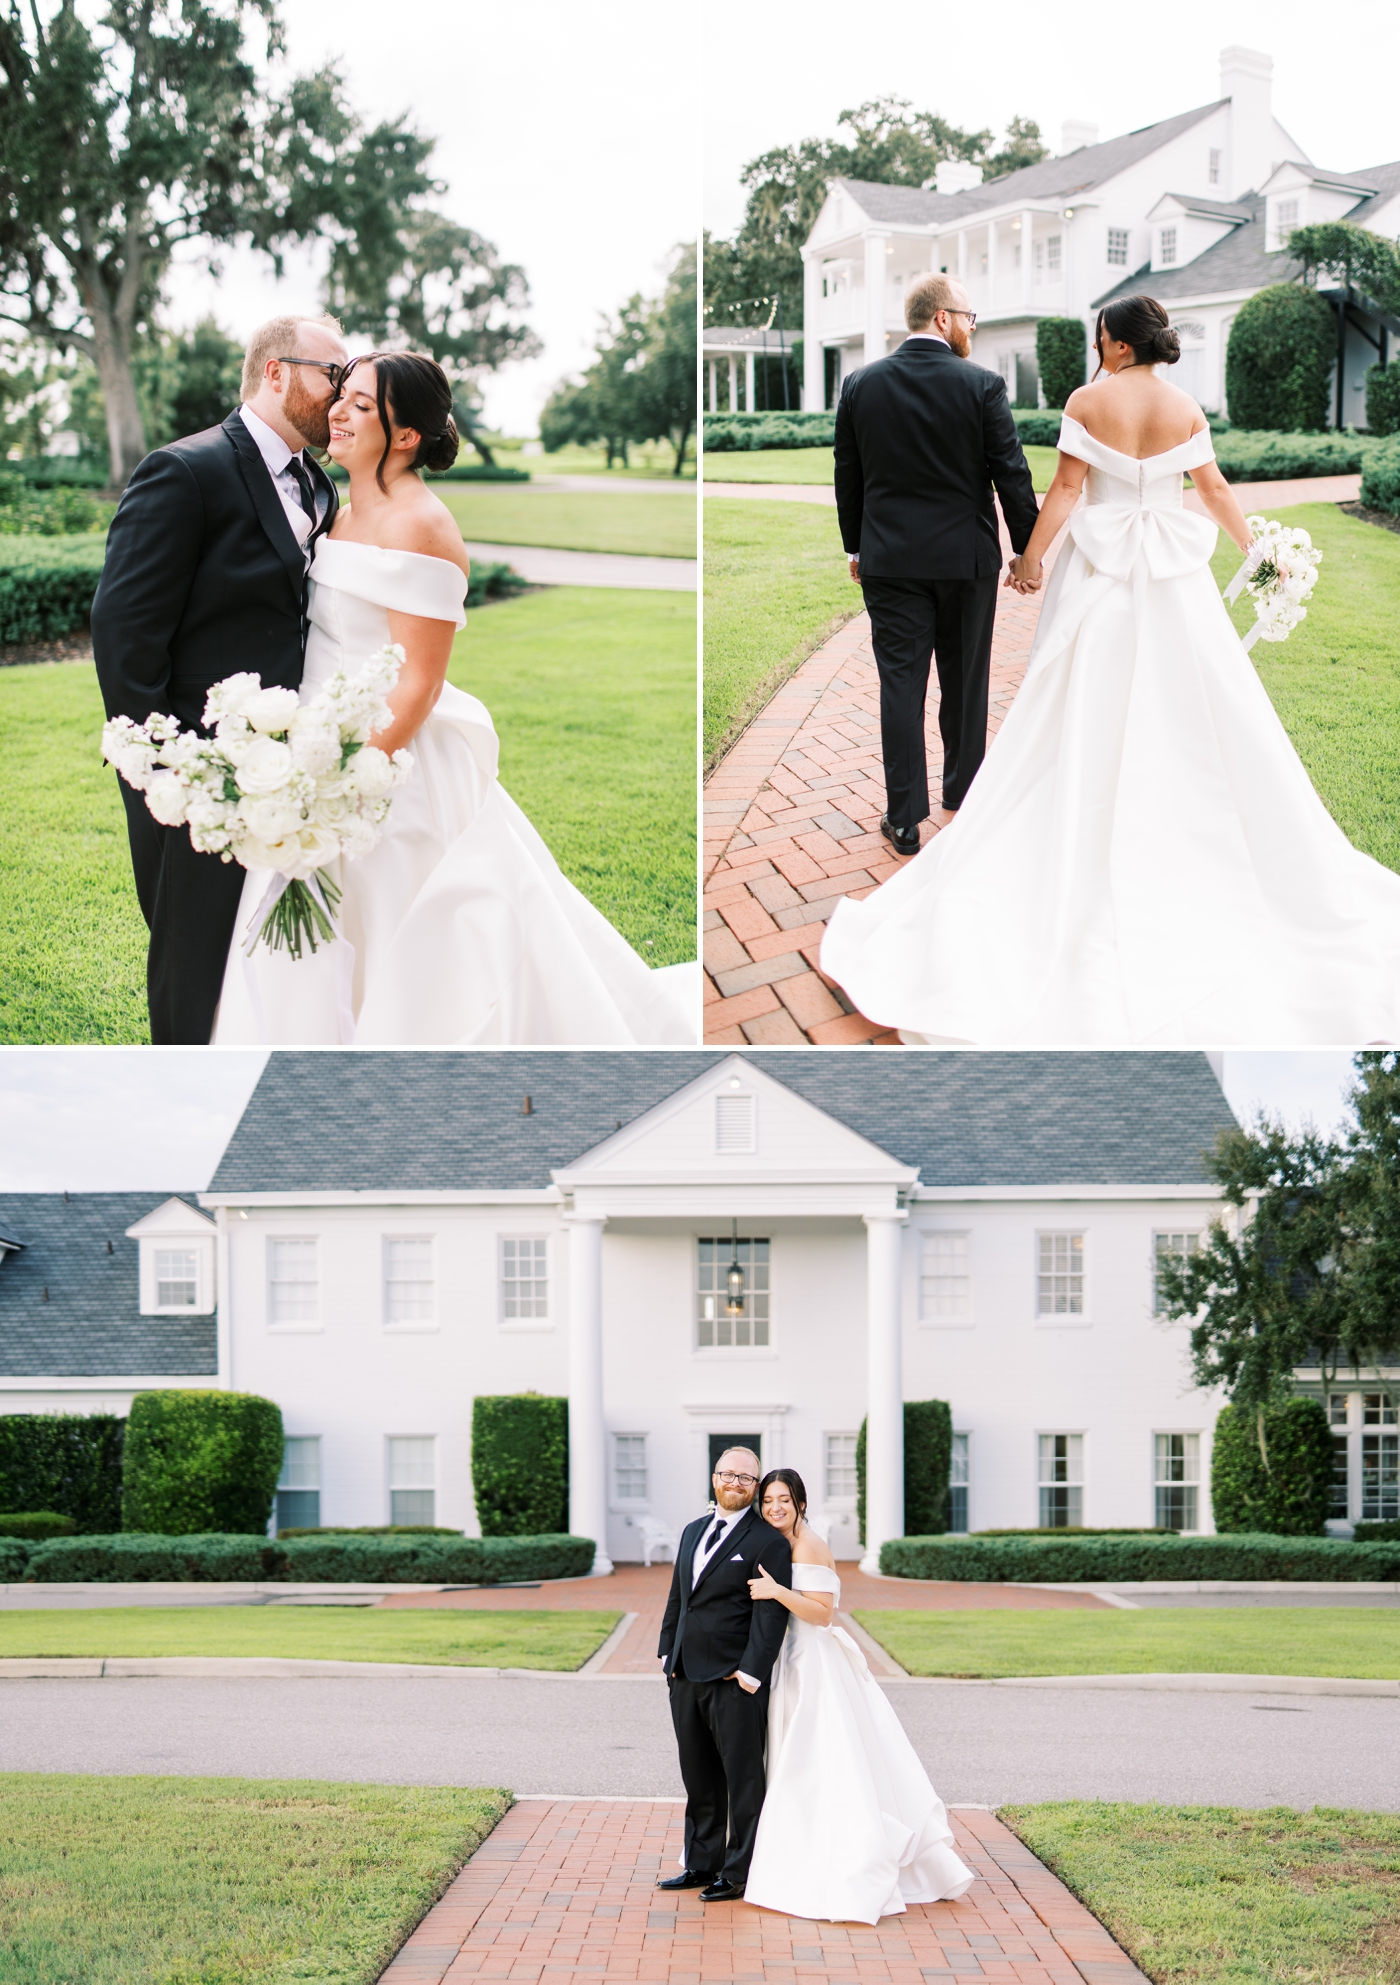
[822,415,1400,1048]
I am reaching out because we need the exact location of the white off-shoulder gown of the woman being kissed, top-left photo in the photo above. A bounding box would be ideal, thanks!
[212,538,697,1048]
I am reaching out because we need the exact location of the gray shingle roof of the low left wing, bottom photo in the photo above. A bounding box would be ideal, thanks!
[0,1193,218,1378]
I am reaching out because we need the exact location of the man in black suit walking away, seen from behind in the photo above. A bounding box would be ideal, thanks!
[836,274,1039,856]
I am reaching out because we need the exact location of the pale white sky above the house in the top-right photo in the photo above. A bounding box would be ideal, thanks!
[705,0,1400,234]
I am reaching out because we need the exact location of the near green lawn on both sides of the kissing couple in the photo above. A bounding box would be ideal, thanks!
[0,579,695,1044]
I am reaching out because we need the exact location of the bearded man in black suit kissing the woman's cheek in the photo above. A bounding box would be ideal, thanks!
[91,318,348,1046]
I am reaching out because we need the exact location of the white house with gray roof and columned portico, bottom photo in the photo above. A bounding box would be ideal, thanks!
[0,1050,1396,1570]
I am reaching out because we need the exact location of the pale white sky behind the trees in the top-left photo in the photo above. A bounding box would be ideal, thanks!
[167,0,699,433]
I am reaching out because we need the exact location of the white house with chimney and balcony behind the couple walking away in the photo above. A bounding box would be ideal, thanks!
[802,48,1400,425]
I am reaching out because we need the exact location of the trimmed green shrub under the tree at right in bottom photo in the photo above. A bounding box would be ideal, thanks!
[1211,1399,1332,1536]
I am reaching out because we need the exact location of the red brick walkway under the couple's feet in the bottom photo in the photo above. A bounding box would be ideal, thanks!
[383,1798,1146,1985]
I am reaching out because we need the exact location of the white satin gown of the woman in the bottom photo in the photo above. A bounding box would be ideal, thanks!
[745,1564,973,1923]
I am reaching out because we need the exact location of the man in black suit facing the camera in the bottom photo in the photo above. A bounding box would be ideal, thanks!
[657,1447,792,1902]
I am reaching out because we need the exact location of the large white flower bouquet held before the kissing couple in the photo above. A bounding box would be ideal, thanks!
[101,645,413,959]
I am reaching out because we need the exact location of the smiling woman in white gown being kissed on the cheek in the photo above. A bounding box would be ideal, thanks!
[212,351,697,1046]
